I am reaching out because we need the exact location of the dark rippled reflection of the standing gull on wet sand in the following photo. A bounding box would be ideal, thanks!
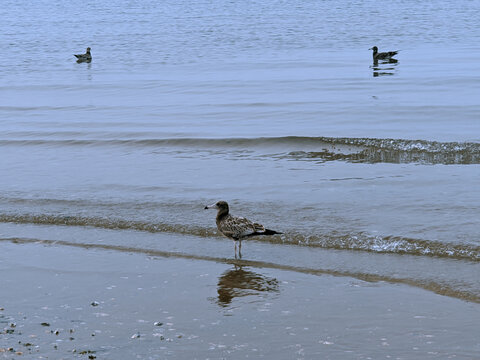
[217,265,279,307]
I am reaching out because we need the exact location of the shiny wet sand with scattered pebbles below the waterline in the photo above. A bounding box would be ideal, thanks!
[0,242,480,359]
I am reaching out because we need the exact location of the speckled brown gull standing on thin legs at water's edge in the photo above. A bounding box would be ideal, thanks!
[205,201,282,259]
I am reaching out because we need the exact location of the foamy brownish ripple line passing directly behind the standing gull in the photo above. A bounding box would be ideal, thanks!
[0,214,480,262]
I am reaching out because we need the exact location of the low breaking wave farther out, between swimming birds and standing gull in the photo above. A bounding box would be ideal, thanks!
[0,134,480,164]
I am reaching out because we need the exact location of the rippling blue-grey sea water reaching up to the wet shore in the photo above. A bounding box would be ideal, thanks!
[0,0,480,316]
